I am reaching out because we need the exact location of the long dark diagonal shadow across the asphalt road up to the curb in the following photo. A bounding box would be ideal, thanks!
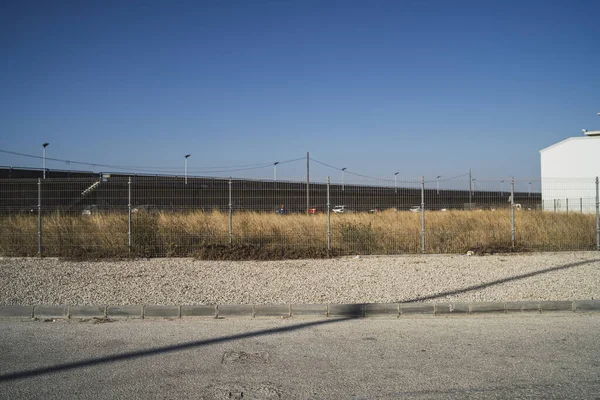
[0,310,360,383]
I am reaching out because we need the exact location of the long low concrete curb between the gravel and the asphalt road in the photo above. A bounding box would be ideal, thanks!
[0,300,600,319]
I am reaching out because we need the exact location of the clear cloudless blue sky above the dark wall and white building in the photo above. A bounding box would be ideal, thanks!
[0,0,600,182]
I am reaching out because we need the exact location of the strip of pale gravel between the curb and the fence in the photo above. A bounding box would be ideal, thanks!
[0,252,600,305]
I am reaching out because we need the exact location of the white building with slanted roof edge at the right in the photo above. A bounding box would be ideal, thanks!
[540,131,600,213]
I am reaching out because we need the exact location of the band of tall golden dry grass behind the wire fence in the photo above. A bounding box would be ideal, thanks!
[0,210,596,258]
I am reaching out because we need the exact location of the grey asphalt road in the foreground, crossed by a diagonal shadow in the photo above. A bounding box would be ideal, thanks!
[0,313,600,399]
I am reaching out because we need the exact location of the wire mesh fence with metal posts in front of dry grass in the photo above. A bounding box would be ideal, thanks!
[0,174,600,259]
